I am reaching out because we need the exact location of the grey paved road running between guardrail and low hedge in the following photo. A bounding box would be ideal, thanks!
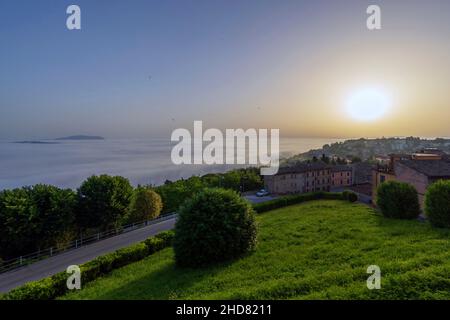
[0,218,175,293]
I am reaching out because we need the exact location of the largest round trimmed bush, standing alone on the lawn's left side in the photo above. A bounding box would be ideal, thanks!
[174,189,257,267]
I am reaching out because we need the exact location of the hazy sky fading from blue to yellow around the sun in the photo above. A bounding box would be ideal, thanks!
[0,0,450,139]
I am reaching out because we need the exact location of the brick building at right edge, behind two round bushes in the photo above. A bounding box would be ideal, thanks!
[372,150,450,206]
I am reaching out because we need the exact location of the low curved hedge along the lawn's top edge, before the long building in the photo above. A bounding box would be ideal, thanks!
[253,191,347,213]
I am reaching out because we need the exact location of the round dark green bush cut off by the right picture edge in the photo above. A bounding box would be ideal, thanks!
[425,180,450,228]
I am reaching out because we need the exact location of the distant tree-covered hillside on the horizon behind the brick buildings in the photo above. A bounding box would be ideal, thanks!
[294,137,450,160]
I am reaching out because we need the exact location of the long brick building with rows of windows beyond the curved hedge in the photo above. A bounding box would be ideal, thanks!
[264,162,353,194]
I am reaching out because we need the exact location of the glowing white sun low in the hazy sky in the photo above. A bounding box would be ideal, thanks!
[346,88,391,122]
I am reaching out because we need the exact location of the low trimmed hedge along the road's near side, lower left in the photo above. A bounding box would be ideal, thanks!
[1,230,174,300]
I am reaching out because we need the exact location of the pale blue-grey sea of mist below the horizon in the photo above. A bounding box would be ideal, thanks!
[0,138,343,189]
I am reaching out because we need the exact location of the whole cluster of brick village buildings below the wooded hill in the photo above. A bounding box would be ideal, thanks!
[264,146,450,205]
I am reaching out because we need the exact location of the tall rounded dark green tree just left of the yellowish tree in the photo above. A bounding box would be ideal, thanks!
[76,175,133,230]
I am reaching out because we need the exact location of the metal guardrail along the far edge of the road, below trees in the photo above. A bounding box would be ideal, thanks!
[0,213,176,273]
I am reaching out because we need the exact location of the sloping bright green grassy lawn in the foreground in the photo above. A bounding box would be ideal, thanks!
[62,200,450,299]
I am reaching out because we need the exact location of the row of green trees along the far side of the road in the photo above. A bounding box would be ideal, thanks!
[0,168,263,261]
